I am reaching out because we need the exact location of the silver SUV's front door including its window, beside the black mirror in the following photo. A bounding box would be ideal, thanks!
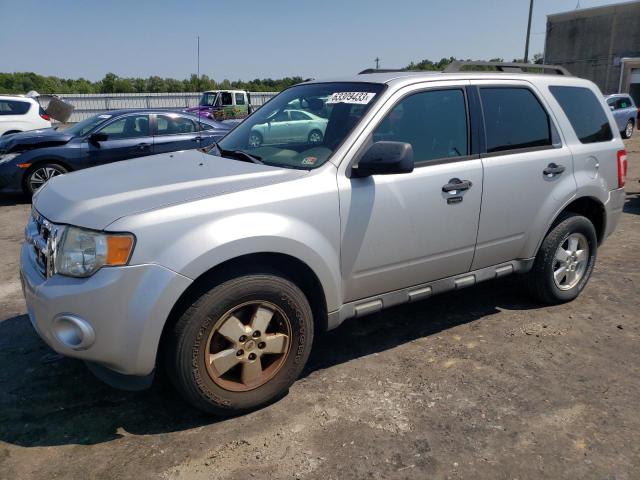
[338,85,482,302]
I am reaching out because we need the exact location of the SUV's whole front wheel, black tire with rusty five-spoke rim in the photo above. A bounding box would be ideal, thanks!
[164,274,313,415]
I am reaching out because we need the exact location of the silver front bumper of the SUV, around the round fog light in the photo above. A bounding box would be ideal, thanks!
[20,243,192,376]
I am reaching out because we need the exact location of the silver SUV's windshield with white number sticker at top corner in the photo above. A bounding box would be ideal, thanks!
[215,82,384,169]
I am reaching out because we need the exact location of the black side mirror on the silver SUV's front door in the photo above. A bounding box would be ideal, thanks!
[351,142,413,178]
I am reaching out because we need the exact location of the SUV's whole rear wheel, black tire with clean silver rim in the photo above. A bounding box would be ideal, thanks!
[527,213,598,304]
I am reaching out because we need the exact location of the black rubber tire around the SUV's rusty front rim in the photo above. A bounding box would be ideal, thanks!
[163,273,313,416]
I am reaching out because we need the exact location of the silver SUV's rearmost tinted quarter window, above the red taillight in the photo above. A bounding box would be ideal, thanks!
[549,87,613,143]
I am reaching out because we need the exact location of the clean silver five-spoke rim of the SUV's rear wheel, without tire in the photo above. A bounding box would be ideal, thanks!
[553,233,589,290]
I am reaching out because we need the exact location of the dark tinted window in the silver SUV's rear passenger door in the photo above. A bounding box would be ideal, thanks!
[480,87,552,153]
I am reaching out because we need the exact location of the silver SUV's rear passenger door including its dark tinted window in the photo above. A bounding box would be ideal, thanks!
[471,80,576,270]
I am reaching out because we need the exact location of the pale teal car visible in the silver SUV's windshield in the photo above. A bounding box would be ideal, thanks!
[247,109,327,148]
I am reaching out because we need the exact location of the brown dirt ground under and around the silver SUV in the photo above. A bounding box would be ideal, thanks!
[0,132,640,480]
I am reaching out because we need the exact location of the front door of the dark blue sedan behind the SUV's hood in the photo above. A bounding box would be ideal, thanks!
[87,114,153,166]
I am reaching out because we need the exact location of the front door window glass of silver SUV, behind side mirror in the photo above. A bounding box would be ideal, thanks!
[373,89,469,162]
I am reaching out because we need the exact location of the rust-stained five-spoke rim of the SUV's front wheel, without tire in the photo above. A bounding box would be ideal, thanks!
[205,301,291,392]
